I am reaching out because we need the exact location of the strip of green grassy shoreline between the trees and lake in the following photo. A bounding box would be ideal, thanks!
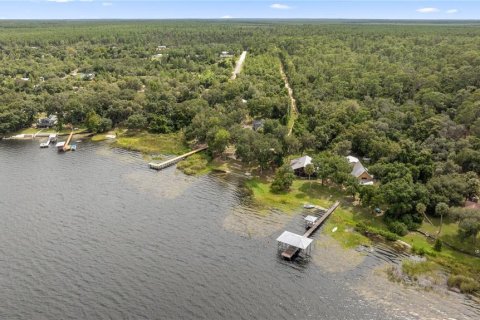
[6,130,480,300]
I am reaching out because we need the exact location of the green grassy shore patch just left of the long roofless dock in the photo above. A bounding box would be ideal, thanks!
[114,131,190,158]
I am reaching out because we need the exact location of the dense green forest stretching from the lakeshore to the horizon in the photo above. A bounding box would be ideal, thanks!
[0,21,480,245]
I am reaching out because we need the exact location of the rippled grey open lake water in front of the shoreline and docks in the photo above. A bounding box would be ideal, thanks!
[0,141,478,320]
